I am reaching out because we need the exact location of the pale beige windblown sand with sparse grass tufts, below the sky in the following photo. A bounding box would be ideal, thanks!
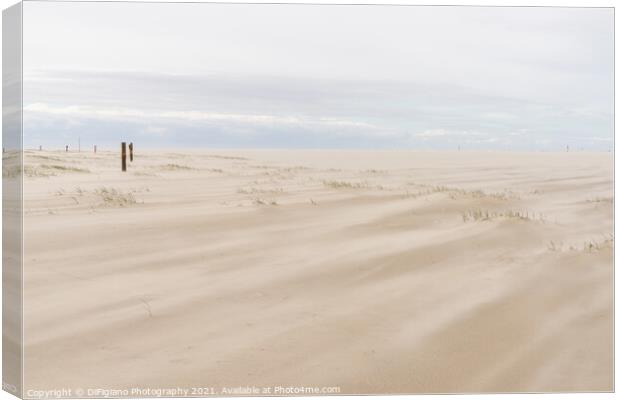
[24,150,613,394]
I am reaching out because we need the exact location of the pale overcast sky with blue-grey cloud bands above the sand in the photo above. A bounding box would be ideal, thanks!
[24,2,613,151]
